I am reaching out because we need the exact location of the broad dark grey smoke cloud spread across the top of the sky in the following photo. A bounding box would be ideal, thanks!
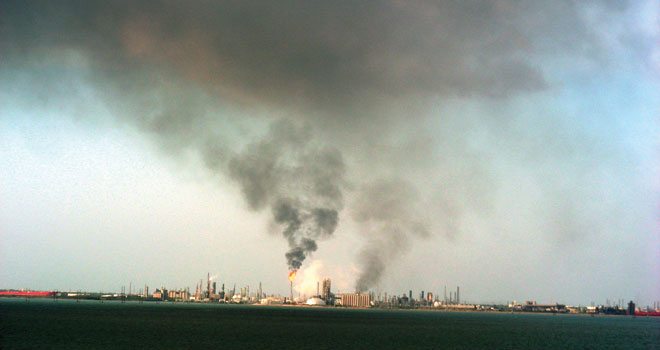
[2,1,628,111]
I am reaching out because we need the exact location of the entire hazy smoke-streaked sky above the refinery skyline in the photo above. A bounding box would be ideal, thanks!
[0,0,660,305]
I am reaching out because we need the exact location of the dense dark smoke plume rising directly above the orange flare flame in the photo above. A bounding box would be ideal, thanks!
[229,121,345,270]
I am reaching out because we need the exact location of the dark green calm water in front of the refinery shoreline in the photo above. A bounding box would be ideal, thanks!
[0,299,660,350]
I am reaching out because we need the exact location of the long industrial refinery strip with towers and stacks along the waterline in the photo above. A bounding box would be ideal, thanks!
[0,272,660,316]
